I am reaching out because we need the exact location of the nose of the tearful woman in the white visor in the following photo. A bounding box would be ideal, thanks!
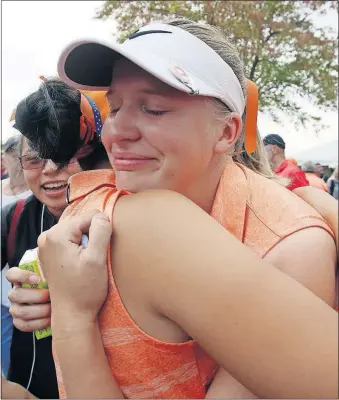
[104,107,141,143]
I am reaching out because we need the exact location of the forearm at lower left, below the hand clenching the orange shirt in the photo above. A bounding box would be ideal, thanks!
[53,324,124,399]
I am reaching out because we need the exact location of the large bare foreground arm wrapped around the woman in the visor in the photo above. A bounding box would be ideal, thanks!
[112,192,338,398]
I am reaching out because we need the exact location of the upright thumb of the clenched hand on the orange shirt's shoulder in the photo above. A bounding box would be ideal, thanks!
[84,213,112,264]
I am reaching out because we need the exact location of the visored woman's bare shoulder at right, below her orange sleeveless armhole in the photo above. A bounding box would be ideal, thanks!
[265,227,337,306]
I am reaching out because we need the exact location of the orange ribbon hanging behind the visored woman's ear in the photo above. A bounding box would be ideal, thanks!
[245,80,259,154]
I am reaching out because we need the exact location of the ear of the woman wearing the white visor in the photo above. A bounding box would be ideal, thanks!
[214,113,242,154]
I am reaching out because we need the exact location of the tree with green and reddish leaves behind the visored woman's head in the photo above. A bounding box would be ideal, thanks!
[96,0,338,128]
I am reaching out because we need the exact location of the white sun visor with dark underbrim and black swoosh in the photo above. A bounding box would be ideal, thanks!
[58,23,245,115]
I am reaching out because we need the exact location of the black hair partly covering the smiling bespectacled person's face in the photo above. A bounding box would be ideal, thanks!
[15,78,107,169]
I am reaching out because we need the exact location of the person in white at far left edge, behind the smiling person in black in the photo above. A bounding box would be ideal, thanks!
[1,131,32,376]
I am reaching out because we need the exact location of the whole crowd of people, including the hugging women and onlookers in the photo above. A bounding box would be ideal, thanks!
[1,19,338,398]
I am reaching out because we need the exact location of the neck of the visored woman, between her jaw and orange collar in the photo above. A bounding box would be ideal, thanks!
[181,158,228,214]
